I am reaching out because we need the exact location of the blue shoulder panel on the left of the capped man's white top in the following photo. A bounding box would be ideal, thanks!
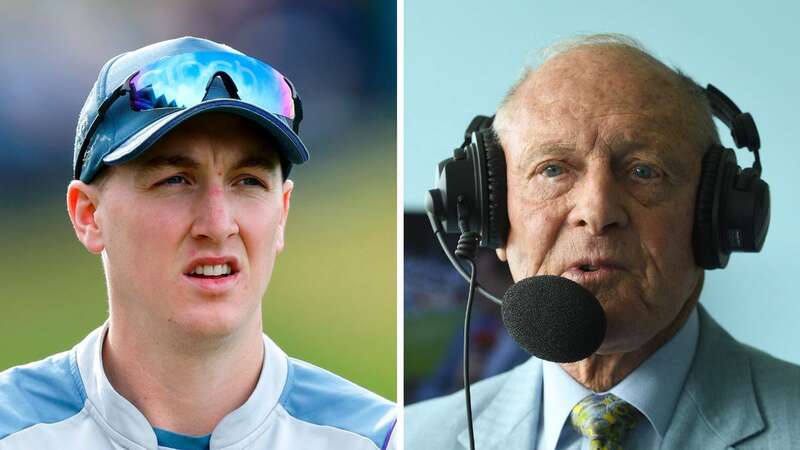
[0,352,86,440]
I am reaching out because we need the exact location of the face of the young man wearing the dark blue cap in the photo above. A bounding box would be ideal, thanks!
[71,113,292,336]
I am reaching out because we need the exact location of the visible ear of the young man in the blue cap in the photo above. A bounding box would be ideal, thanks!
[67,180,105,255]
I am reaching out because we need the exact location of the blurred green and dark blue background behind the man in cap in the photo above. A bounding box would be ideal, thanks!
[0,0,396,399]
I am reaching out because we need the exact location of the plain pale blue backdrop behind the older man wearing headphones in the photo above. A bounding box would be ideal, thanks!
[404,0,800,400]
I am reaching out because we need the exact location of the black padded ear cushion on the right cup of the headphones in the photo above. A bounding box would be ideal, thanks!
[692,145,730,269]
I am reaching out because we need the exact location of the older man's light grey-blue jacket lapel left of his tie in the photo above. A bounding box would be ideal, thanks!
[458,358,542,450]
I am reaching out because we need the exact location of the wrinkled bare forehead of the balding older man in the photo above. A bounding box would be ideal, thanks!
[499,48,701,158]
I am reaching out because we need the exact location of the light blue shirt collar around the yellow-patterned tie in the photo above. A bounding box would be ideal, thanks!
[540,308,699,449]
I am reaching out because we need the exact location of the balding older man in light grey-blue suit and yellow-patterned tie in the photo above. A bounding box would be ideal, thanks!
[405,36,800,450]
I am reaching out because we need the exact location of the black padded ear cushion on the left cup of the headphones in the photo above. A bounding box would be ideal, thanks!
[476,128,508,248]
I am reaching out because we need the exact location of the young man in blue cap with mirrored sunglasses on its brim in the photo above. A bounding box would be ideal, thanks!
[0,37,395,450]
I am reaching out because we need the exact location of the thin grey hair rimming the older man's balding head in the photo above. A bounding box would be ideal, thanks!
[494,33,720,149]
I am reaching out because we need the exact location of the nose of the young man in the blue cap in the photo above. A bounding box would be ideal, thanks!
[192,187,239,242]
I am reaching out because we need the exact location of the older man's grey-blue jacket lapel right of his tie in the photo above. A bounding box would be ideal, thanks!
[662,305,764,449]
